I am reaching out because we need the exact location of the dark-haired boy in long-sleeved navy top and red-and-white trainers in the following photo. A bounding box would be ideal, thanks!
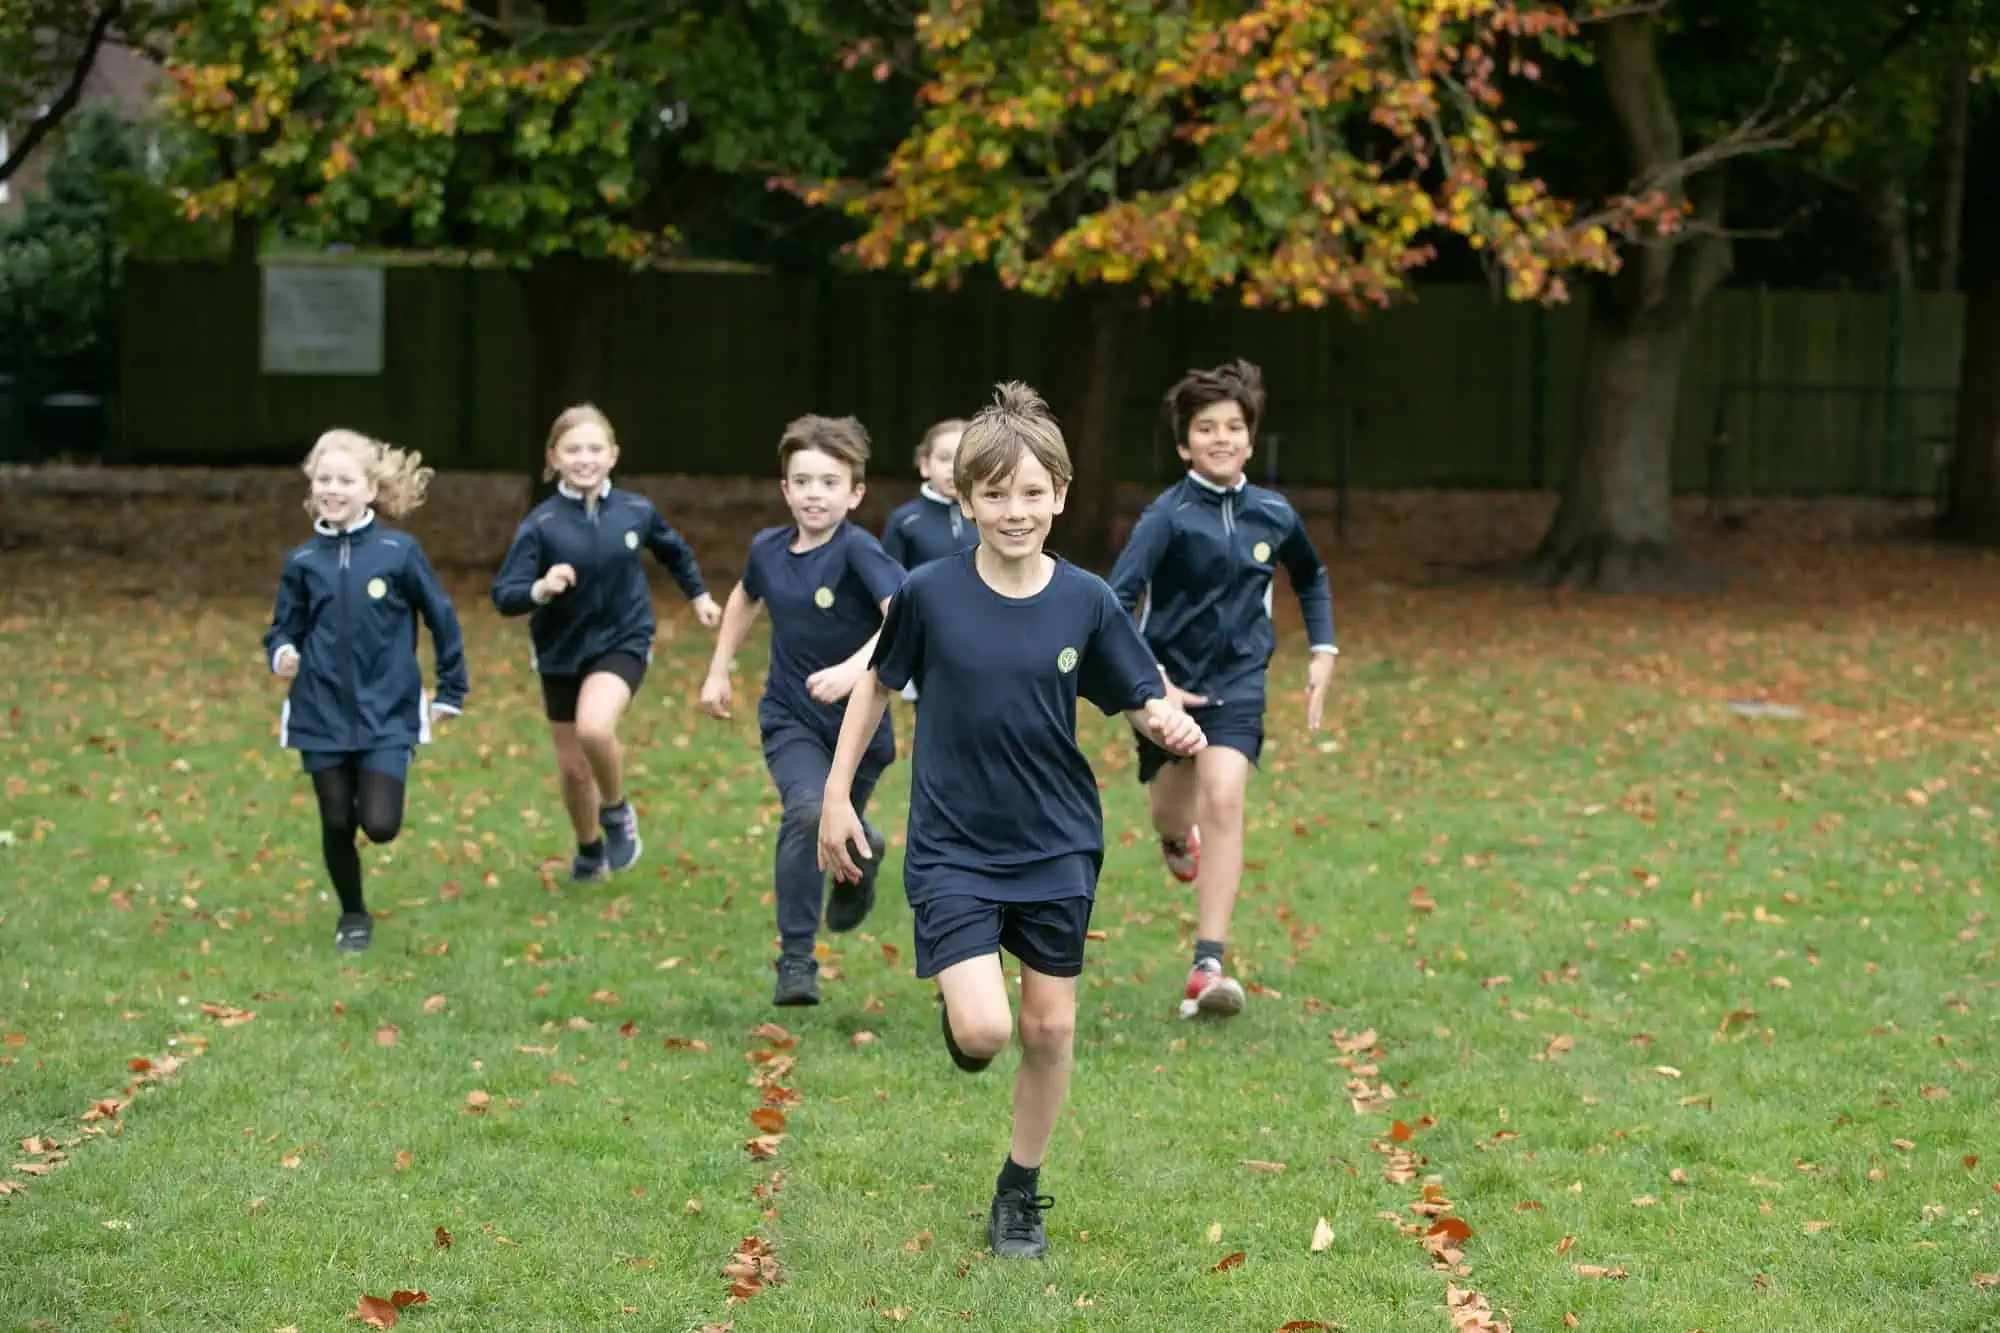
[1110,360,1338,1017]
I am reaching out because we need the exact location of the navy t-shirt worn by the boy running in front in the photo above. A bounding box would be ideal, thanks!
[874,550,1166,905]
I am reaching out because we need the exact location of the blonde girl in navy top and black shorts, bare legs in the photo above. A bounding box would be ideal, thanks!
[492,402,722,883]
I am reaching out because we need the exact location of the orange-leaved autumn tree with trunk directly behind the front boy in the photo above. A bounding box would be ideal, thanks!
[788,0,1680,558]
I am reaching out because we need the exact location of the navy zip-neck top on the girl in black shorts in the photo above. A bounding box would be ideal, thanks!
[492,482,708,677]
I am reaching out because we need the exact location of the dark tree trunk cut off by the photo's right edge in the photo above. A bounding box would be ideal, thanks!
[1938,98,2000,546]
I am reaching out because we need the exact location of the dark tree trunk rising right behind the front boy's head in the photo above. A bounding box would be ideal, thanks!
[1050,286,1130,572]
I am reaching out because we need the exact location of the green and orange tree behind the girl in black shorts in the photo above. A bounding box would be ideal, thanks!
[168,0,900,488]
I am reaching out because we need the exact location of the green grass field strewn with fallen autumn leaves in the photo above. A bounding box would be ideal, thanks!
[0,474,2000,1333]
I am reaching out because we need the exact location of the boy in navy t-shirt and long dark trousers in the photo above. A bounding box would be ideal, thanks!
[702,416,902,1005]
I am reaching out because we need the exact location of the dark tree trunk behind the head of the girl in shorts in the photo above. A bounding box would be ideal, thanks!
[520,254,620,506]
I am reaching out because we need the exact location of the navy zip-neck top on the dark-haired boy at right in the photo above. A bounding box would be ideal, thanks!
[1110,472,1334,703]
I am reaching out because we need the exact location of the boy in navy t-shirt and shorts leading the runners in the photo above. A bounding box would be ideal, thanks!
[820,384,1202,1259]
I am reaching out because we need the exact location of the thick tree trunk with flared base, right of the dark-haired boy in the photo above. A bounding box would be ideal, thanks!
[1528,10,1730,592]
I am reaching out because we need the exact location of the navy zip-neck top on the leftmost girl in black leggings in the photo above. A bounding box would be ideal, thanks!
[264,510,468,751]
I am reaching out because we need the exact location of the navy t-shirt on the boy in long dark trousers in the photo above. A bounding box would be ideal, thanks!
[744,522,902,753]
